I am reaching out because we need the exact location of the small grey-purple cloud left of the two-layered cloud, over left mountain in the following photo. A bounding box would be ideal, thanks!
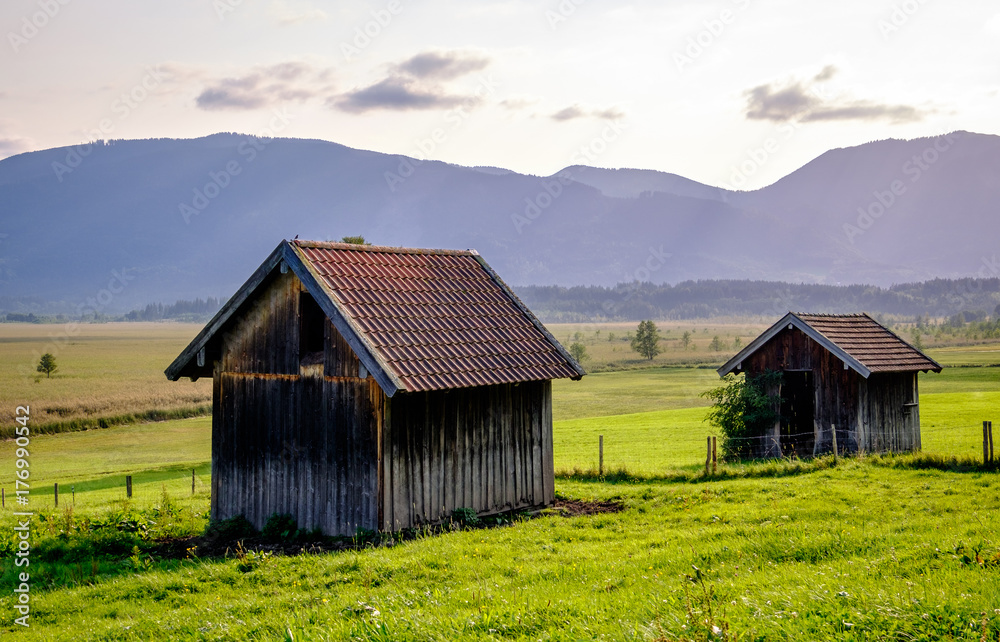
[195,62,330,110]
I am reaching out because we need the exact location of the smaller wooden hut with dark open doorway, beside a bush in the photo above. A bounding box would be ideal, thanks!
[718,312,941,457]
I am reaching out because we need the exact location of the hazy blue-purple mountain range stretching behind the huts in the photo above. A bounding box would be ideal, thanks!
[0,132,1000,311]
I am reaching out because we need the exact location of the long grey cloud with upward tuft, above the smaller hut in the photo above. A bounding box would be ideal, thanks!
[745,65,927,123]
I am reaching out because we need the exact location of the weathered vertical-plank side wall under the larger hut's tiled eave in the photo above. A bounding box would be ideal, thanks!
[381,381,555,530]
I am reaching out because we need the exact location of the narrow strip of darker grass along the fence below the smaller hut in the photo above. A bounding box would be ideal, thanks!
[556,453,1000,484]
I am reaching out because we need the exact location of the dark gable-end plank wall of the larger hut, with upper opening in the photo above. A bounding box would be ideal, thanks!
[212,274,383,535]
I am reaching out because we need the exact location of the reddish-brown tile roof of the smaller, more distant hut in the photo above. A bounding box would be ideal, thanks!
[795,314,941,372]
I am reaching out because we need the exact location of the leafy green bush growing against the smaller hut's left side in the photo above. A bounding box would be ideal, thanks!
[702,370,781,459]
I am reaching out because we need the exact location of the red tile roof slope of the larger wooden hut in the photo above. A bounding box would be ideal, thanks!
[293,241,583,391]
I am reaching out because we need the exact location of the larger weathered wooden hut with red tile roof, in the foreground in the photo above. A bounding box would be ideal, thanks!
[166,241,584,535]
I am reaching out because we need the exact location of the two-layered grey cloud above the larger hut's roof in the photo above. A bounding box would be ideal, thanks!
[327,51,490,113]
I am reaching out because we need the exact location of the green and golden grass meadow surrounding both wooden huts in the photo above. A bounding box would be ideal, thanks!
[0,322,1000,641]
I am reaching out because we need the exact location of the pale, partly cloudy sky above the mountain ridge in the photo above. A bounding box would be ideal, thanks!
[0,0,1000,189]
